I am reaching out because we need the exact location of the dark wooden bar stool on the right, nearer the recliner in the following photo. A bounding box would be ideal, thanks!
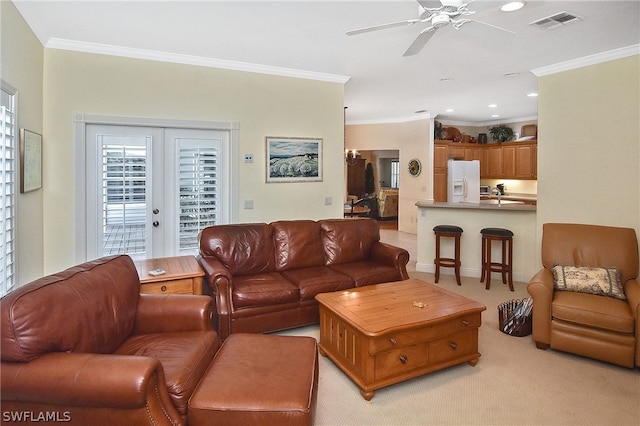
[480,228,513,291]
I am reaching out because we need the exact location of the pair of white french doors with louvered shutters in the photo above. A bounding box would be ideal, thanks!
[85,124,230,259]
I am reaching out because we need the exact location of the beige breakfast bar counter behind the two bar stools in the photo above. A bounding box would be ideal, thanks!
[416,199,539,282]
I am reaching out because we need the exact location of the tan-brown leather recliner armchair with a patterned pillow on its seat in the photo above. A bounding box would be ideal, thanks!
[527,223,640,368]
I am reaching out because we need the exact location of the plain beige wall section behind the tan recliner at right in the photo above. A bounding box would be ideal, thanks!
[537,55,640,266]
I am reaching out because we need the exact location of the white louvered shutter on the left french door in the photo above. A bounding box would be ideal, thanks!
[100,136,148,258]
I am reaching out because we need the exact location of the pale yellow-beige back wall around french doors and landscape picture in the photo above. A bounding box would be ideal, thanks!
[44,49,344,272]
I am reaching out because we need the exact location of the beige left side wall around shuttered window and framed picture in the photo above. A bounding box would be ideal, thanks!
[0,1,44,284]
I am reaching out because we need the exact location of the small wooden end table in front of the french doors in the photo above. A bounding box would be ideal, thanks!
[134,256,204,294]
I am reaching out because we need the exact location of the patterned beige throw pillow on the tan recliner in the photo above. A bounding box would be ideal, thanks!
[552,265,627,300]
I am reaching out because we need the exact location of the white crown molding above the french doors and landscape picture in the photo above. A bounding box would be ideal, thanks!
[45,38,351,84]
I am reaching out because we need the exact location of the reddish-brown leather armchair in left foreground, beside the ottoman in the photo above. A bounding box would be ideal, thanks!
[0,256,220,425]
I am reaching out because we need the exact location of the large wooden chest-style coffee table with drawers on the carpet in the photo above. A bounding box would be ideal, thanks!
[316,279,486,401]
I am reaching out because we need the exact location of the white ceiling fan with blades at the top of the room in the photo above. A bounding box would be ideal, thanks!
[347,0,514,56]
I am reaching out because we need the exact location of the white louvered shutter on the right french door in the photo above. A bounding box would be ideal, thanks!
[178,143,220,253]
